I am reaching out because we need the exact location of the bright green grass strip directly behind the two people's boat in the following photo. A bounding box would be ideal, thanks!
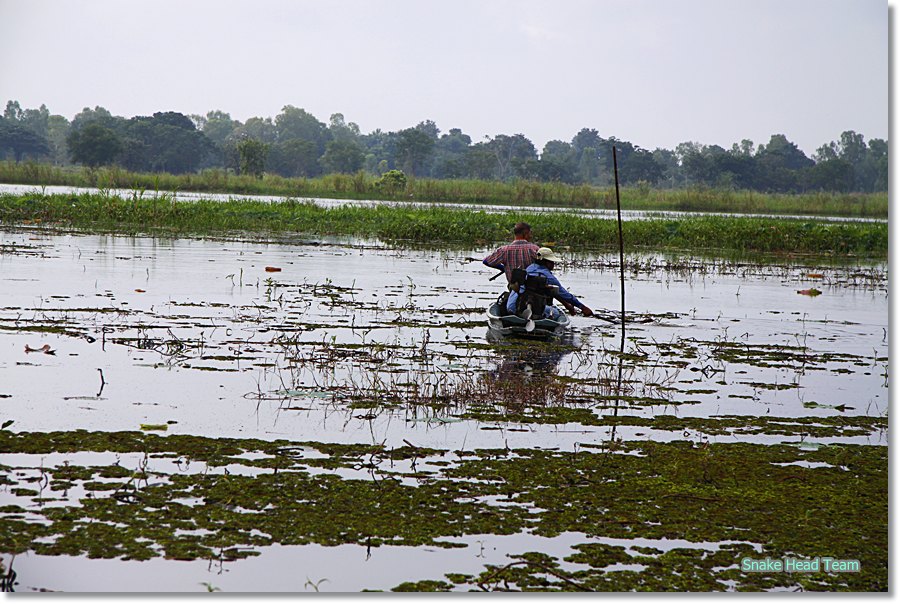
[0,194,888,257]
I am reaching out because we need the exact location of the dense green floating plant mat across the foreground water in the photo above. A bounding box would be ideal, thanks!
[0,431,887,591]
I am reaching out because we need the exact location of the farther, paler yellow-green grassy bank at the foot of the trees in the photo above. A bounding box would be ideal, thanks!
[0,162,888,218]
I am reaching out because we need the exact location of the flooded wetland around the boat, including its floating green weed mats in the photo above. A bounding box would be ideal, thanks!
[0,230,888,592]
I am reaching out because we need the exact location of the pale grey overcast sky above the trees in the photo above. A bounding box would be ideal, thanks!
[0,0,894,154]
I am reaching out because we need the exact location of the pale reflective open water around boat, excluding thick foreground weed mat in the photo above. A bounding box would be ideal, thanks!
[0,230,888,591]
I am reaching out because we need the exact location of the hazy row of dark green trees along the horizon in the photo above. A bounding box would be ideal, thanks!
[0,101,888,193]
